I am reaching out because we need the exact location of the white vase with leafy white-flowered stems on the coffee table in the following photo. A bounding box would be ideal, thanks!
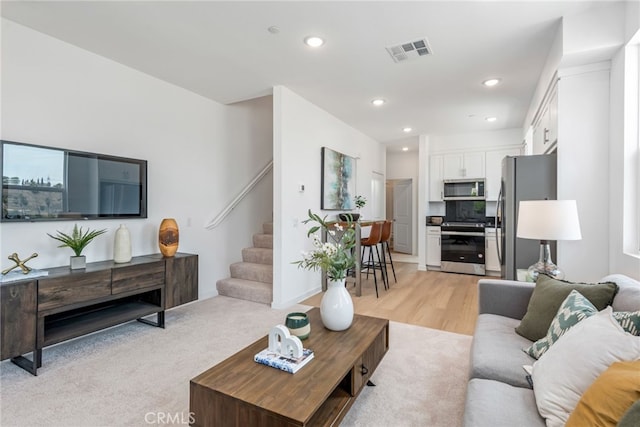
[294,210,356,331]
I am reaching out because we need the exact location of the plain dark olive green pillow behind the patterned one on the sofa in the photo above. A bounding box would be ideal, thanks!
[516,274,618,341]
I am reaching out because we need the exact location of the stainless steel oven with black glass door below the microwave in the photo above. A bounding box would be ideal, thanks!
[440,222,485,276]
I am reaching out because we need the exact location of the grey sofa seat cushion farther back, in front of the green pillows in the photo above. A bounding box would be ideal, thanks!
[470,314,535,388]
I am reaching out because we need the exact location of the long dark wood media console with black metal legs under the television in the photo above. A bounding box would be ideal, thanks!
[0,253,198,375]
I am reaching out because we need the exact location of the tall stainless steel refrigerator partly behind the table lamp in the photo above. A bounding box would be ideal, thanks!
[496,154,557,280]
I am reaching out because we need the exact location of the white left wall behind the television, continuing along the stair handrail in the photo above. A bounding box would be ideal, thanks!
[0,19,272,298]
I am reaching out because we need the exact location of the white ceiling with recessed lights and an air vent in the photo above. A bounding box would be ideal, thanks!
[2,0,616,149]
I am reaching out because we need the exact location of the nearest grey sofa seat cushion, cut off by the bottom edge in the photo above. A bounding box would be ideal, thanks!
[462,378,545,427]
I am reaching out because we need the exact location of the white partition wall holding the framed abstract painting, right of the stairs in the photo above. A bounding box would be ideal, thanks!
[273,86,385,308]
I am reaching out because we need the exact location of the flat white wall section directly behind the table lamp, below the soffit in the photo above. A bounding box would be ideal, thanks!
[556,63,609,281]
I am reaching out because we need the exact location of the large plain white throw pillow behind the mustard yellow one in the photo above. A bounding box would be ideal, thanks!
[532,307,640,427]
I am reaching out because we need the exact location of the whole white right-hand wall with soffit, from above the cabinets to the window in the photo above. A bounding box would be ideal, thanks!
[523,2,640,280]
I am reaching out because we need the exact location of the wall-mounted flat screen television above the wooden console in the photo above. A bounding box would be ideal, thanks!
[0,141,147,222]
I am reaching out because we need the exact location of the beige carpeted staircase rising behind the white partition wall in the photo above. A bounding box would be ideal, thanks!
[216,223,273,304]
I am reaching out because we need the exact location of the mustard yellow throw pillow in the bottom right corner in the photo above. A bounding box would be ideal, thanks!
[566,360,640,427]
